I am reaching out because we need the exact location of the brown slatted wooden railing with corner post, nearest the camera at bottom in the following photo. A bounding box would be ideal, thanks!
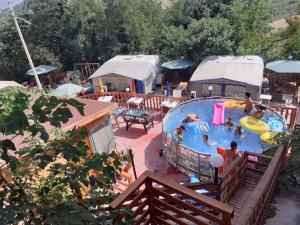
[110,171,233,225]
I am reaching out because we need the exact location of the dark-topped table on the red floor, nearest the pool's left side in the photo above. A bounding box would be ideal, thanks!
[123,109,156,134]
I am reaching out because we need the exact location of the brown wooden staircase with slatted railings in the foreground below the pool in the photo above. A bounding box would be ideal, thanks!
[110,146,286,225]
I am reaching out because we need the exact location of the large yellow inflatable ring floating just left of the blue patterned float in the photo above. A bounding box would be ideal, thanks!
[240,116,270,134]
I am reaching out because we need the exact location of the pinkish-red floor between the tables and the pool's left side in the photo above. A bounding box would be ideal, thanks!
[114,116,188,182]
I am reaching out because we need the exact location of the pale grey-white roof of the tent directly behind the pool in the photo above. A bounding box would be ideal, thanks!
[190,56,264,86]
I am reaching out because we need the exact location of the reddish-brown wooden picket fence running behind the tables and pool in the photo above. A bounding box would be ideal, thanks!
[79,92,297,129]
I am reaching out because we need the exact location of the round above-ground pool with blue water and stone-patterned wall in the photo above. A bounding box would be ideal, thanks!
[163,98,286,177]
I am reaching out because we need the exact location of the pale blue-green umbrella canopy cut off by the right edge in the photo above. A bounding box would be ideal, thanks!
[266,60,300,73]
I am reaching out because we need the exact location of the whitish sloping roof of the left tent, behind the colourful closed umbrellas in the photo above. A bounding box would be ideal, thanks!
[90,55,159,80]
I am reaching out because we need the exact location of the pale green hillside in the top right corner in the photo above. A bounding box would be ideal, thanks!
[267,0,300,20]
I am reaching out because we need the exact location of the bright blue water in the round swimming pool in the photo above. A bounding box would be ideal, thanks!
[163,99,286,154]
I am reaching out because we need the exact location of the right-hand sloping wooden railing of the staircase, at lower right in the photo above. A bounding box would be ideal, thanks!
[235,145,286,225]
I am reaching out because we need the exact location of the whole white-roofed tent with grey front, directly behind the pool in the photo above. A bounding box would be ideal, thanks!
[190,56,264,100]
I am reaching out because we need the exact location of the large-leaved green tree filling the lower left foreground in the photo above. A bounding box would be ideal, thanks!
[0,88,130,224]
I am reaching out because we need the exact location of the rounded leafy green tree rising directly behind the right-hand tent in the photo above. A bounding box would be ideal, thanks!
[185,18,233,62]
